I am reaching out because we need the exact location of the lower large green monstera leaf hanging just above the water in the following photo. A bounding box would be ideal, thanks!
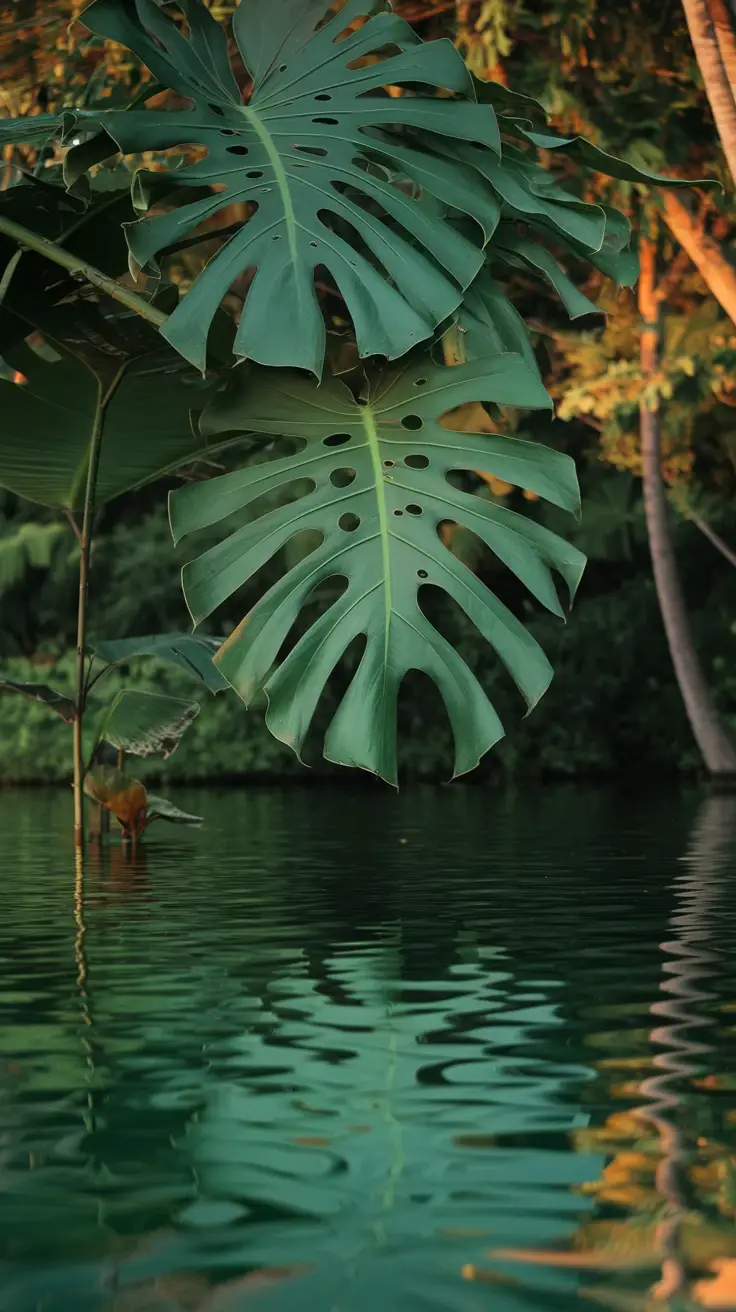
[171,353,584,782]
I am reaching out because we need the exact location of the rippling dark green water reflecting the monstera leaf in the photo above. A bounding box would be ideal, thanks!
[0,787,736,1312]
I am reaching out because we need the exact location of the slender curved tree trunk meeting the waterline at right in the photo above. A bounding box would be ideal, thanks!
[639,237,736,774]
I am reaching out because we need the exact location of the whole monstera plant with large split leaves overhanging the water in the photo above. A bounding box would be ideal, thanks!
[0,0,708,823]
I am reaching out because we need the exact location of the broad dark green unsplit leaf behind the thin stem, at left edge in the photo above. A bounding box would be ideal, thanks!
[0,349,217,510]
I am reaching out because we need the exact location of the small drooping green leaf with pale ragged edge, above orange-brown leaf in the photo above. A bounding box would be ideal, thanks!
[97,689,199,758]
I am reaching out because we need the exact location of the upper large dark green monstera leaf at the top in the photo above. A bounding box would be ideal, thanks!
[66,0,500,375]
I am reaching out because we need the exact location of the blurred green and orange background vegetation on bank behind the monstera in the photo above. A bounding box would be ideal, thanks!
[0,0,736,782]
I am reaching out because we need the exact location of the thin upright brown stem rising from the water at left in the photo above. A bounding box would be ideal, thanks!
[73,365,125,848]
